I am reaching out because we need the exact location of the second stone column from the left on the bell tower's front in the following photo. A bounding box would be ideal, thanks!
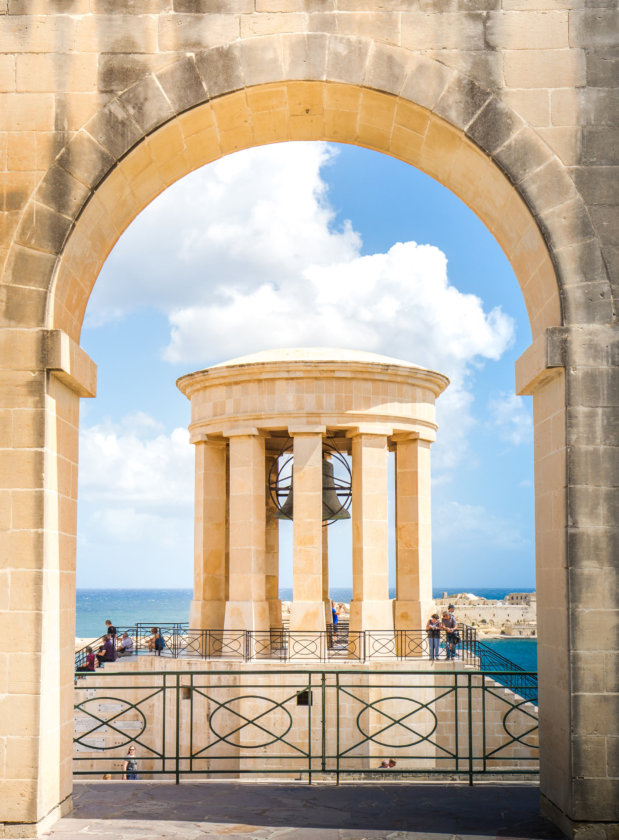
[224,430,269,631]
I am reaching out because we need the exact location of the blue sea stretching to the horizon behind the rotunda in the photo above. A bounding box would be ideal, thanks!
[75,586,537,671]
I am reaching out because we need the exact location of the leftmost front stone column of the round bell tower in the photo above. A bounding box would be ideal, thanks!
[189,435,227,630]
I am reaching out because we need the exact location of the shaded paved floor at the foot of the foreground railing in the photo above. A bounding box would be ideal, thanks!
[41,782,563,840]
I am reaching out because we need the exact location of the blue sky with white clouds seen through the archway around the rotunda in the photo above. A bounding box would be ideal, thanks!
[78,143,534,590]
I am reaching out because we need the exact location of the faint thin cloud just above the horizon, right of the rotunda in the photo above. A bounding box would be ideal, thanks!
[432,501,530,551]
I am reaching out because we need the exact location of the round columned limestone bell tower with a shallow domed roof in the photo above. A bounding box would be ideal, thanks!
[177,348,449,632]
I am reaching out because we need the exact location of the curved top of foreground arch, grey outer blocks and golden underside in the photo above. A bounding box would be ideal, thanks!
[2,34,612,340]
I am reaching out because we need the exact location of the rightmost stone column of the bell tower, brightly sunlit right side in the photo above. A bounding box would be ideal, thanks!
[394,435,432,630]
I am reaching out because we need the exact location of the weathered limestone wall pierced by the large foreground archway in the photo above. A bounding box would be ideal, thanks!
[0,0,619,838]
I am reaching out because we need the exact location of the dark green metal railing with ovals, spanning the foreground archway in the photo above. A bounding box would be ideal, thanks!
[74,666,539,784]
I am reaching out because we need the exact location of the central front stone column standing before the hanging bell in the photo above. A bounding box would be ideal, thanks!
[290,427,325,630]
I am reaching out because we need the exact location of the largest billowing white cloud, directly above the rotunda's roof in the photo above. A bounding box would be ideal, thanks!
[88,143,514,480]
